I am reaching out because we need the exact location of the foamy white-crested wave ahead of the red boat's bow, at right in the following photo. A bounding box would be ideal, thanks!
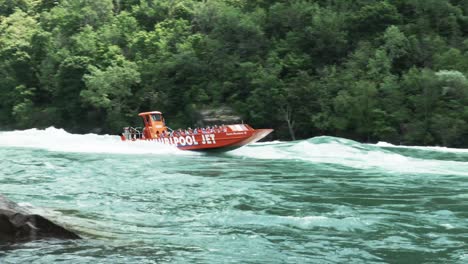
[232,137,468,176]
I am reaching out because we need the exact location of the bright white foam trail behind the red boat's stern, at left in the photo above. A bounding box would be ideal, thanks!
[0,127,187,154]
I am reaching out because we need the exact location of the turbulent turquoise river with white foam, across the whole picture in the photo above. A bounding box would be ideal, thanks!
[0,128,468,263]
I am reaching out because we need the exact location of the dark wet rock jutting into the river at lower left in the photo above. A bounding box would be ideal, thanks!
[0,195,80,243]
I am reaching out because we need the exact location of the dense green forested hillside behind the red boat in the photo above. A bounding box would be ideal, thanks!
[0,0,468,147]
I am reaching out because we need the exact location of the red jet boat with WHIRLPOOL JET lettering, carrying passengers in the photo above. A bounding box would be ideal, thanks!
[121,111,273,151]
